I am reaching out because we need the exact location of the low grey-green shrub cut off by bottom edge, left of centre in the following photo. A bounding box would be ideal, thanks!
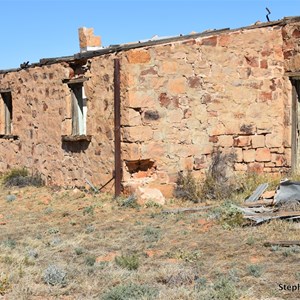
[99,283,158,300]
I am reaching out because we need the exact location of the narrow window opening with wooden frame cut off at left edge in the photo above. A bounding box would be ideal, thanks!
[0,91,13,135]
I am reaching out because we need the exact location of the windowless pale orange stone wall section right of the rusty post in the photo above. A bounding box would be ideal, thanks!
[122,25,299,194]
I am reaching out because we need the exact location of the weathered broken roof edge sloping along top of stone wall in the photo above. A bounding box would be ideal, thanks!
[0,16,300,74]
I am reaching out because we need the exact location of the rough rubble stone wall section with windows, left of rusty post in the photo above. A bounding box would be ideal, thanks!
[0,56,114,186]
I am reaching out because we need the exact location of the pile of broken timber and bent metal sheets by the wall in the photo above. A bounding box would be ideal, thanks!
[237,180,300,224]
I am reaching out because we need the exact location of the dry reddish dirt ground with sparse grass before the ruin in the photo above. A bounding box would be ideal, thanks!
[0,187,300,300]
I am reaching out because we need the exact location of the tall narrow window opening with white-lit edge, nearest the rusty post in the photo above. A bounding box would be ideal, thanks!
[69,83,87,135]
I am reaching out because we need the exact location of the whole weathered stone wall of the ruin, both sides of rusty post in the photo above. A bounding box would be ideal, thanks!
[0,18,300,195]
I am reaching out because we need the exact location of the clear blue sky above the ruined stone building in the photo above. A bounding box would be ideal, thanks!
[0,0,300,69]
